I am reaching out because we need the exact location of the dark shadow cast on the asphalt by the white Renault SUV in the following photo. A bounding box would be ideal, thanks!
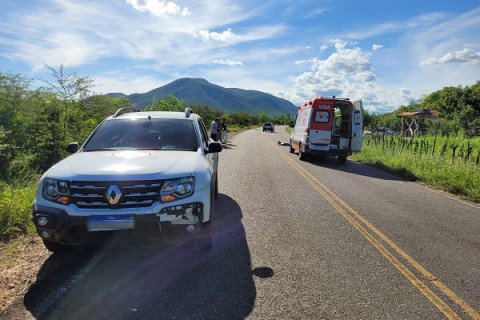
[24,194,256,319]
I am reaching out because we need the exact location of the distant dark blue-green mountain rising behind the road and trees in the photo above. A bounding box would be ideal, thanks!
[108,78,296,116]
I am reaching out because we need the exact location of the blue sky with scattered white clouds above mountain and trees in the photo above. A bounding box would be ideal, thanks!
[0,0,480,113]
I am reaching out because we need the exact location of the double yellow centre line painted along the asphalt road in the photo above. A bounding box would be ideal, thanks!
[274,145,480,319]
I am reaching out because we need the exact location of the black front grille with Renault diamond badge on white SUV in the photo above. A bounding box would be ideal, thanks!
[69,180,162,209]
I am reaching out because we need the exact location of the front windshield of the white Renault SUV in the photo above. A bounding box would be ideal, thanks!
[84,118,198,151]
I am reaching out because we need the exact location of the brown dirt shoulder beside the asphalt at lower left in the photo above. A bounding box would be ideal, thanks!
[0,235,51,318]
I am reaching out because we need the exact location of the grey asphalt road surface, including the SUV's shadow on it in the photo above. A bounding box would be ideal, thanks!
[15,128,480,319]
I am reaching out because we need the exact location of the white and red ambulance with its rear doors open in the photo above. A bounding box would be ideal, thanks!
[290,96,363,164]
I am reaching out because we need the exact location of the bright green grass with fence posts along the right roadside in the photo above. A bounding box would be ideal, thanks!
[352,134,480,202]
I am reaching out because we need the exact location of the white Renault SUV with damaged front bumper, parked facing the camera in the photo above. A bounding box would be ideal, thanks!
[33,108,222,252]
